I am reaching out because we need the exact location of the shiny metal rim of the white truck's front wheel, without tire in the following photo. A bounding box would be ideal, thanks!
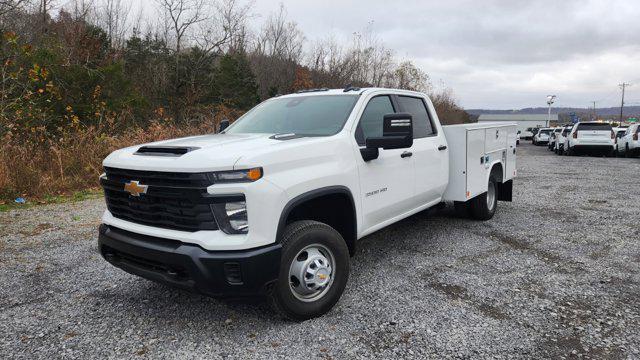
[289,244,335,302]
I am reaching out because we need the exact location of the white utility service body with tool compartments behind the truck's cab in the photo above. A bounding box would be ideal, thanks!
[443,123,517,201]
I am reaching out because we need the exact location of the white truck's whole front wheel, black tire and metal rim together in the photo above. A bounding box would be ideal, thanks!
[268,220,349,320]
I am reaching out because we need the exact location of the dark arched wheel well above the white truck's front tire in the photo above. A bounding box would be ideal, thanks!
[278,189,357,256]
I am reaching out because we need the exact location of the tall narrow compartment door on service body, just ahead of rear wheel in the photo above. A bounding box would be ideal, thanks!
[466,129,484,200]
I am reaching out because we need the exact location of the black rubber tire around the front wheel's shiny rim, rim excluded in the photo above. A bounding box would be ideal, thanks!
[268,220,349,321]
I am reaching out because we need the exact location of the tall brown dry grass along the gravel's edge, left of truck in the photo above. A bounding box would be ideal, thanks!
[0,119,214,201]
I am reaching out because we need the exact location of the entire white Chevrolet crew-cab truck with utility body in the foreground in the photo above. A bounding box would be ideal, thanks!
[98,87,516,320]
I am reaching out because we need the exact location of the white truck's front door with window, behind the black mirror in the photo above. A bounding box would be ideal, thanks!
[356,95,415,231]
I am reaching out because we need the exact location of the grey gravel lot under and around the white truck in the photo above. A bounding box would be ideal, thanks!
[0,144,640,359]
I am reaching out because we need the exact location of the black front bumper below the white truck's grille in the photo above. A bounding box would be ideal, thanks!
[98,224,282,297]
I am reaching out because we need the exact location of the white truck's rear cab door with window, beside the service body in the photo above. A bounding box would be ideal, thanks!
[396,95,449,207]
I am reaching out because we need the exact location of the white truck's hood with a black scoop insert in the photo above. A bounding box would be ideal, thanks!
[103,134,309,172]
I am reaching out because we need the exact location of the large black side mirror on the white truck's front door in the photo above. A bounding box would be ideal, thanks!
[360,113,413,161]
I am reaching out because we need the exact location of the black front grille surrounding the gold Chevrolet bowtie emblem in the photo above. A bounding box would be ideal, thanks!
[100,167,218,232]
